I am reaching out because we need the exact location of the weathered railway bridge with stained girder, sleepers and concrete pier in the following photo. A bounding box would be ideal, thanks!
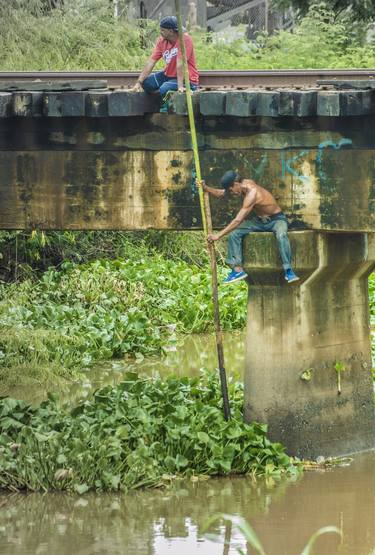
[0,71,375,457]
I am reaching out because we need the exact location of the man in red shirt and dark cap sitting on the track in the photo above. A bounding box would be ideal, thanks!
[133,16,199,112]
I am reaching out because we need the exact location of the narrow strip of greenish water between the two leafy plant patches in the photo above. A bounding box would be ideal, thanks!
[7,331,245,403]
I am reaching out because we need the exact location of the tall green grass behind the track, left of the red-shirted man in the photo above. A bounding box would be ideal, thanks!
[0,0,157,71]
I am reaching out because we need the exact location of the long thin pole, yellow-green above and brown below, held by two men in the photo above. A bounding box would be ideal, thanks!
[175,0,230,420]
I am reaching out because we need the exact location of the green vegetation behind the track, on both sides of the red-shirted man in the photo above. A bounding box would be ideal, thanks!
[0,0,375,71]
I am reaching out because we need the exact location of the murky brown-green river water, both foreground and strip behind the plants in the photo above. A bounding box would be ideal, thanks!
[0,333,375,555]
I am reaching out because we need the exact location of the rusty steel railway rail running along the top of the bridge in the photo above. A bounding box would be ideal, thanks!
[0,69,375,89]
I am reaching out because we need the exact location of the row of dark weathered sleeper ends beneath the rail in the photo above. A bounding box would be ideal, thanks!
[0,89,375,118]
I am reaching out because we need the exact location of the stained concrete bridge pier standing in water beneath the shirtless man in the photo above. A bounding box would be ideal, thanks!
[244,231,375,458]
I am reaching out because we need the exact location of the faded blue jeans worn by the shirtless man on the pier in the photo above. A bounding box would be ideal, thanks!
[227,212,292,270]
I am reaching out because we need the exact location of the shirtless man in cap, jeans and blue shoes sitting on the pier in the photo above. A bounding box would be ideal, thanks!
[202,170,299,284]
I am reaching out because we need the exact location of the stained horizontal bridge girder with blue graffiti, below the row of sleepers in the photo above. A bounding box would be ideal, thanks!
[0,116,375,232]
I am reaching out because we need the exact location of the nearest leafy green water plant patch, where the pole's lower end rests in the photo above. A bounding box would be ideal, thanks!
[0,373,296,493]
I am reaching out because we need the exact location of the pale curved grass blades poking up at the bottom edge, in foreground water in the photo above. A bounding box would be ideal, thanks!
[206,514,342,555]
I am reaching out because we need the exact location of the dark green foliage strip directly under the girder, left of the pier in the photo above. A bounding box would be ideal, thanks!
[0,230,224,281]
